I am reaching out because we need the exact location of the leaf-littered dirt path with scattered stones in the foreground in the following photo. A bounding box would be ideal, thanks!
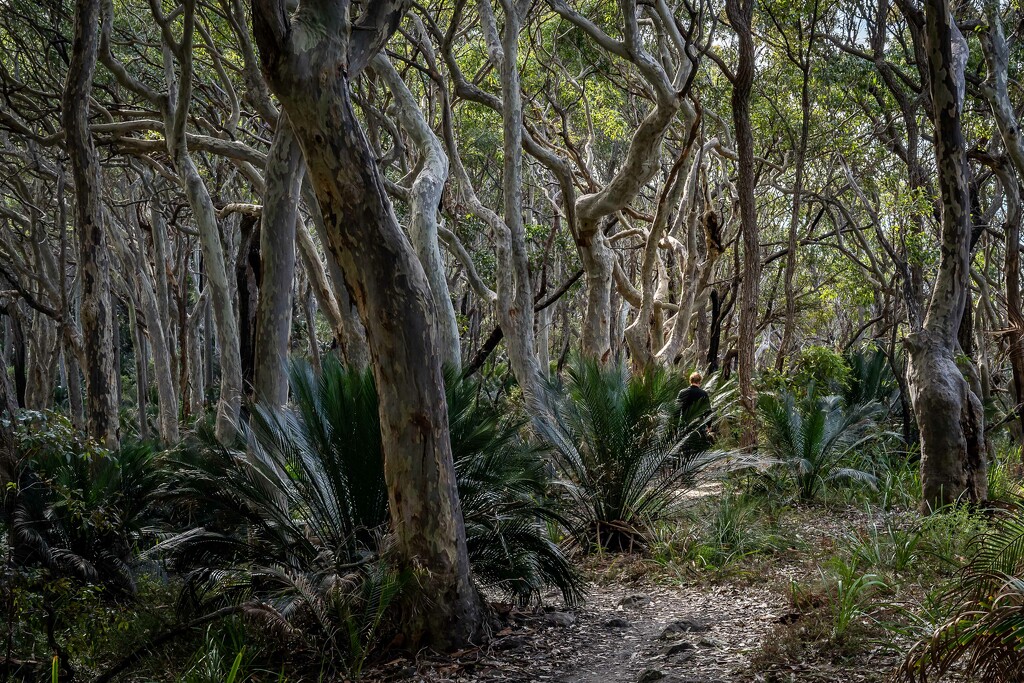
[366,507,921,683]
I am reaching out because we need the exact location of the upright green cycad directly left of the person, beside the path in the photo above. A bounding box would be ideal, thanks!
[541,358,714,551]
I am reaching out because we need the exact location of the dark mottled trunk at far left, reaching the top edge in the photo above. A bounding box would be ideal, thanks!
[61,0,120,449]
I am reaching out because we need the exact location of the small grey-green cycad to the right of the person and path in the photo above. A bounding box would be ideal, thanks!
[758,388,880,501]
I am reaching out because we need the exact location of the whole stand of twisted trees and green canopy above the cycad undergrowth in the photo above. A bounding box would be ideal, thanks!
[0,0,1024,655]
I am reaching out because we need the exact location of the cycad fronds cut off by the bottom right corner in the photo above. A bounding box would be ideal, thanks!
[899,501,1024,683]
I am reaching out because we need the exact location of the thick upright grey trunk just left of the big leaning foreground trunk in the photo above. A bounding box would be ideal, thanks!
[253,116,303,405]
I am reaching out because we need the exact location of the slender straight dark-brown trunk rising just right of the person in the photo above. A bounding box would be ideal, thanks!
[726,0,761,447]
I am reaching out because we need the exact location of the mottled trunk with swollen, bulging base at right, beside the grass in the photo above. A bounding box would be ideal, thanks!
[905,0,987,512]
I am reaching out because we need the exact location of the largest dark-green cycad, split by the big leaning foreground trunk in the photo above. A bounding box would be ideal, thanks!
[156,359,581,664]
